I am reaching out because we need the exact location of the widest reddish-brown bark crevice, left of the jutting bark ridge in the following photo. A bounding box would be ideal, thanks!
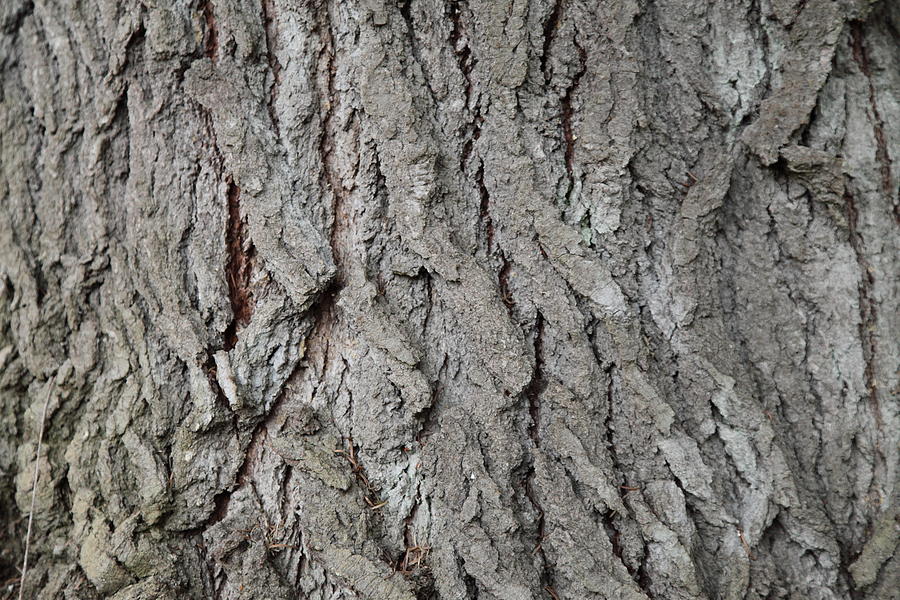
[225,177,256,350]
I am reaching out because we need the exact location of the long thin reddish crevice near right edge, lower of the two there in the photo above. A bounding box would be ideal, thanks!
[844,190,882,431]
